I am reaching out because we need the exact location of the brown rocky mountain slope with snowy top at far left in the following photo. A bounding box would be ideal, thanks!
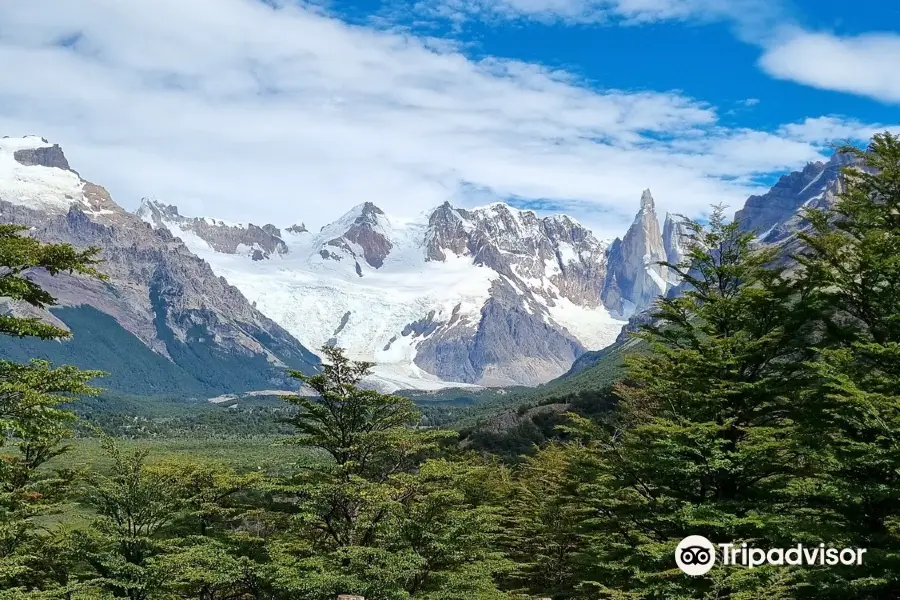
[0,137,318,395]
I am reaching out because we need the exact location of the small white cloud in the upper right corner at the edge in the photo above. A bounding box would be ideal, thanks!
[760,31,900,103]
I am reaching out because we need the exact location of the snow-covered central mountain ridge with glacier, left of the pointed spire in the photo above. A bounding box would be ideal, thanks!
[139,195,621,387]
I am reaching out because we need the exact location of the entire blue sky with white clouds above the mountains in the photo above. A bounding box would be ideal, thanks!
[0,0,900,237]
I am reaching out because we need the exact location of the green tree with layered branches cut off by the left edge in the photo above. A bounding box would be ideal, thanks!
[0,225,102,597]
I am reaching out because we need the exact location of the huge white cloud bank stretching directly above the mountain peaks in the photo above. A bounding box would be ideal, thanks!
[0,0,884,236]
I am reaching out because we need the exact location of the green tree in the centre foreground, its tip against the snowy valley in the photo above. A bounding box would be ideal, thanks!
[270,347,502,600]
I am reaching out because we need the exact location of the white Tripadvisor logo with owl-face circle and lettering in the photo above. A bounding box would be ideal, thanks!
[675,535,866,576]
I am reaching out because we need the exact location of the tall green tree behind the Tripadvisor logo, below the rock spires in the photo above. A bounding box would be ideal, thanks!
[569,207,813,599]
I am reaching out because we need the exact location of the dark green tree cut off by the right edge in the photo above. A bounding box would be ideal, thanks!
[799,133,900,598]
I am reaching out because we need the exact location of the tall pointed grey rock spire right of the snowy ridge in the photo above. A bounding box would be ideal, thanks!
[602,190,668,317]
